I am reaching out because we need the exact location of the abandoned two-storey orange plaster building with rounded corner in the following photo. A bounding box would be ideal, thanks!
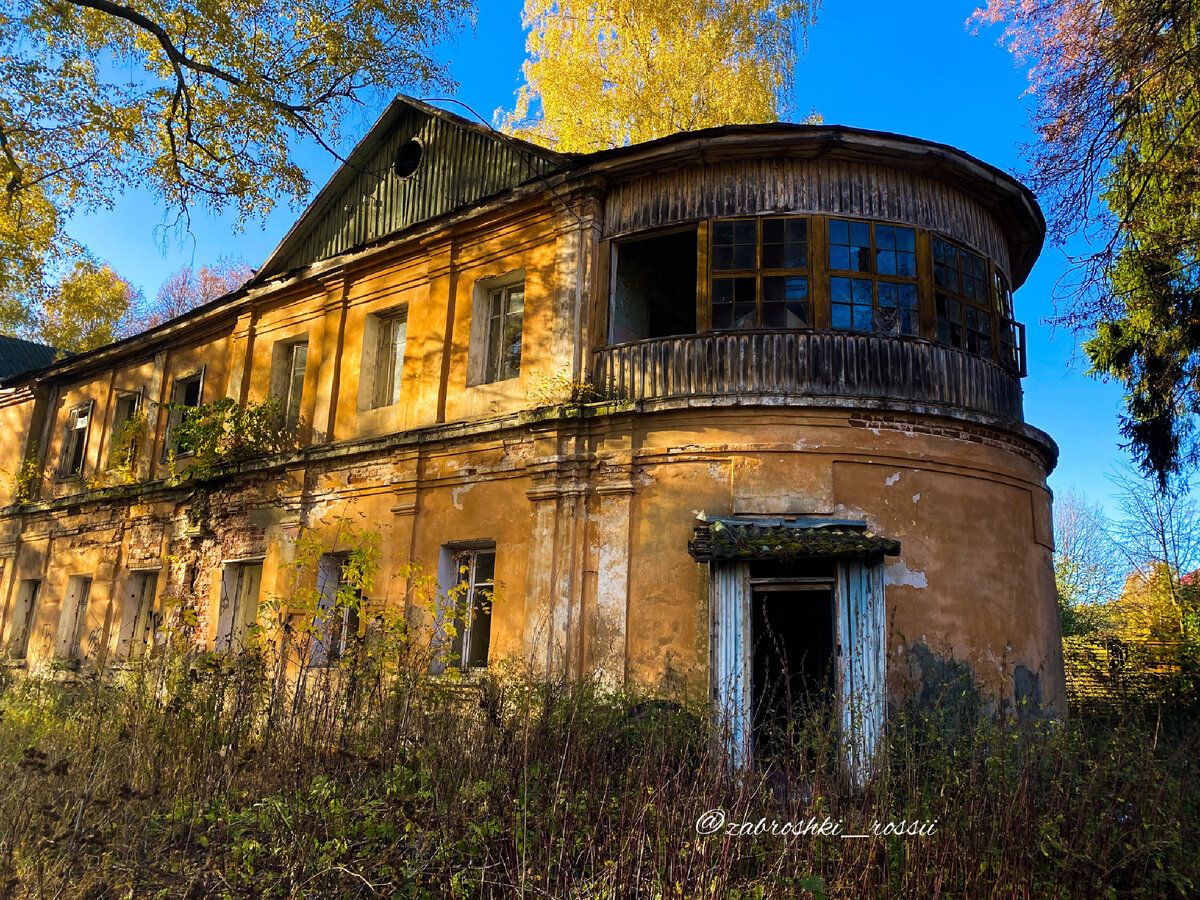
[0,98,1064,763]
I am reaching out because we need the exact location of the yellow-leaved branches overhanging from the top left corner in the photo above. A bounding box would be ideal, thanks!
[0,0,473,330]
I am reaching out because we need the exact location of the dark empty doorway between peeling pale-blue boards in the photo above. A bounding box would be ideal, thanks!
[750,560,834,754]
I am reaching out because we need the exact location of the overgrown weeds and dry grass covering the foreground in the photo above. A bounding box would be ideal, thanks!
[0,653,1200,899]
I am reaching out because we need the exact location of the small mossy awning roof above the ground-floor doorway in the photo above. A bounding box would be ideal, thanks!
[688,518,900,563]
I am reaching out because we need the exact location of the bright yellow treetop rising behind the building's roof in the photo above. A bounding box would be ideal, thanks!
[497,0,816,152]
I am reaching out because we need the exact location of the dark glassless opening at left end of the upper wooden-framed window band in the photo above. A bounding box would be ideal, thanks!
[610,229,696,343]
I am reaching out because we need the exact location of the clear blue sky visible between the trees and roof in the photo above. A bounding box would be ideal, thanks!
[71,0,1126,506]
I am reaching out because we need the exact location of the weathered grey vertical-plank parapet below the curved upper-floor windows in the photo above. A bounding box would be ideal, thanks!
[593,331,1022,422]
